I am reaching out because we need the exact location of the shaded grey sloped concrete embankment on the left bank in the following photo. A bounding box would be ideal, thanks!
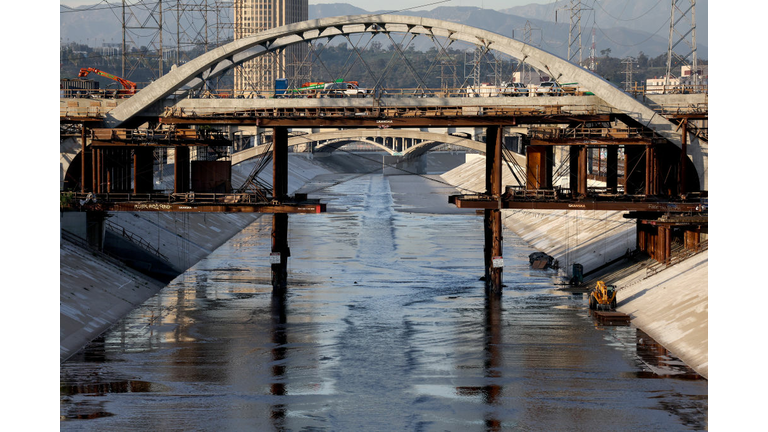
[59,154,330,361]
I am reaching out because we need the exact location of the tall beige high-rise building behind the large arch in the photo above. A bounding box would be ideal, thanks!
[234,0,309,93]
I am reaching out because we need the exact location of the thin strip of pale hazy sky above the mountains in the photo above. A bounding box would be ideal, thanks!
[59,0,554,11]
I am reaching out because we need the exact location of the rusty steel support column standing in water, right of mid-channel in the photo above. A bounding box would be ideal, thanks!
[483,126,504,297]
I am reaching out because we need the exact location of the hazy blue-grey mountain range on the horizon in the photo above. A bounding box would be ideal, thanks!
[60,0,708,59]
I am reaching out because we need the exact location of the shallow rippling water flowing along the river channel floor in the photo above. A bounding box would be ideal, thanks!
[60,167,708,432]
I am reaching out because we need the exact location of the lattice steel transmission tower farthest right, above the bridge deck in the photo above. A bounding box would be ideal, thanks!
[664,0,699,86]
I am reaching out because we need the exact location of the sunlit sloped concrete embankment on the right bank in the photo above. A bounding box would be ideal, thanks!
[442,157,708,378]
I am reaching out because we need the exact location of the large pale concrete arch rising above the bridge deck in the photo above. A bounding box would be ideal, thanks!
[105,14,707,188]
